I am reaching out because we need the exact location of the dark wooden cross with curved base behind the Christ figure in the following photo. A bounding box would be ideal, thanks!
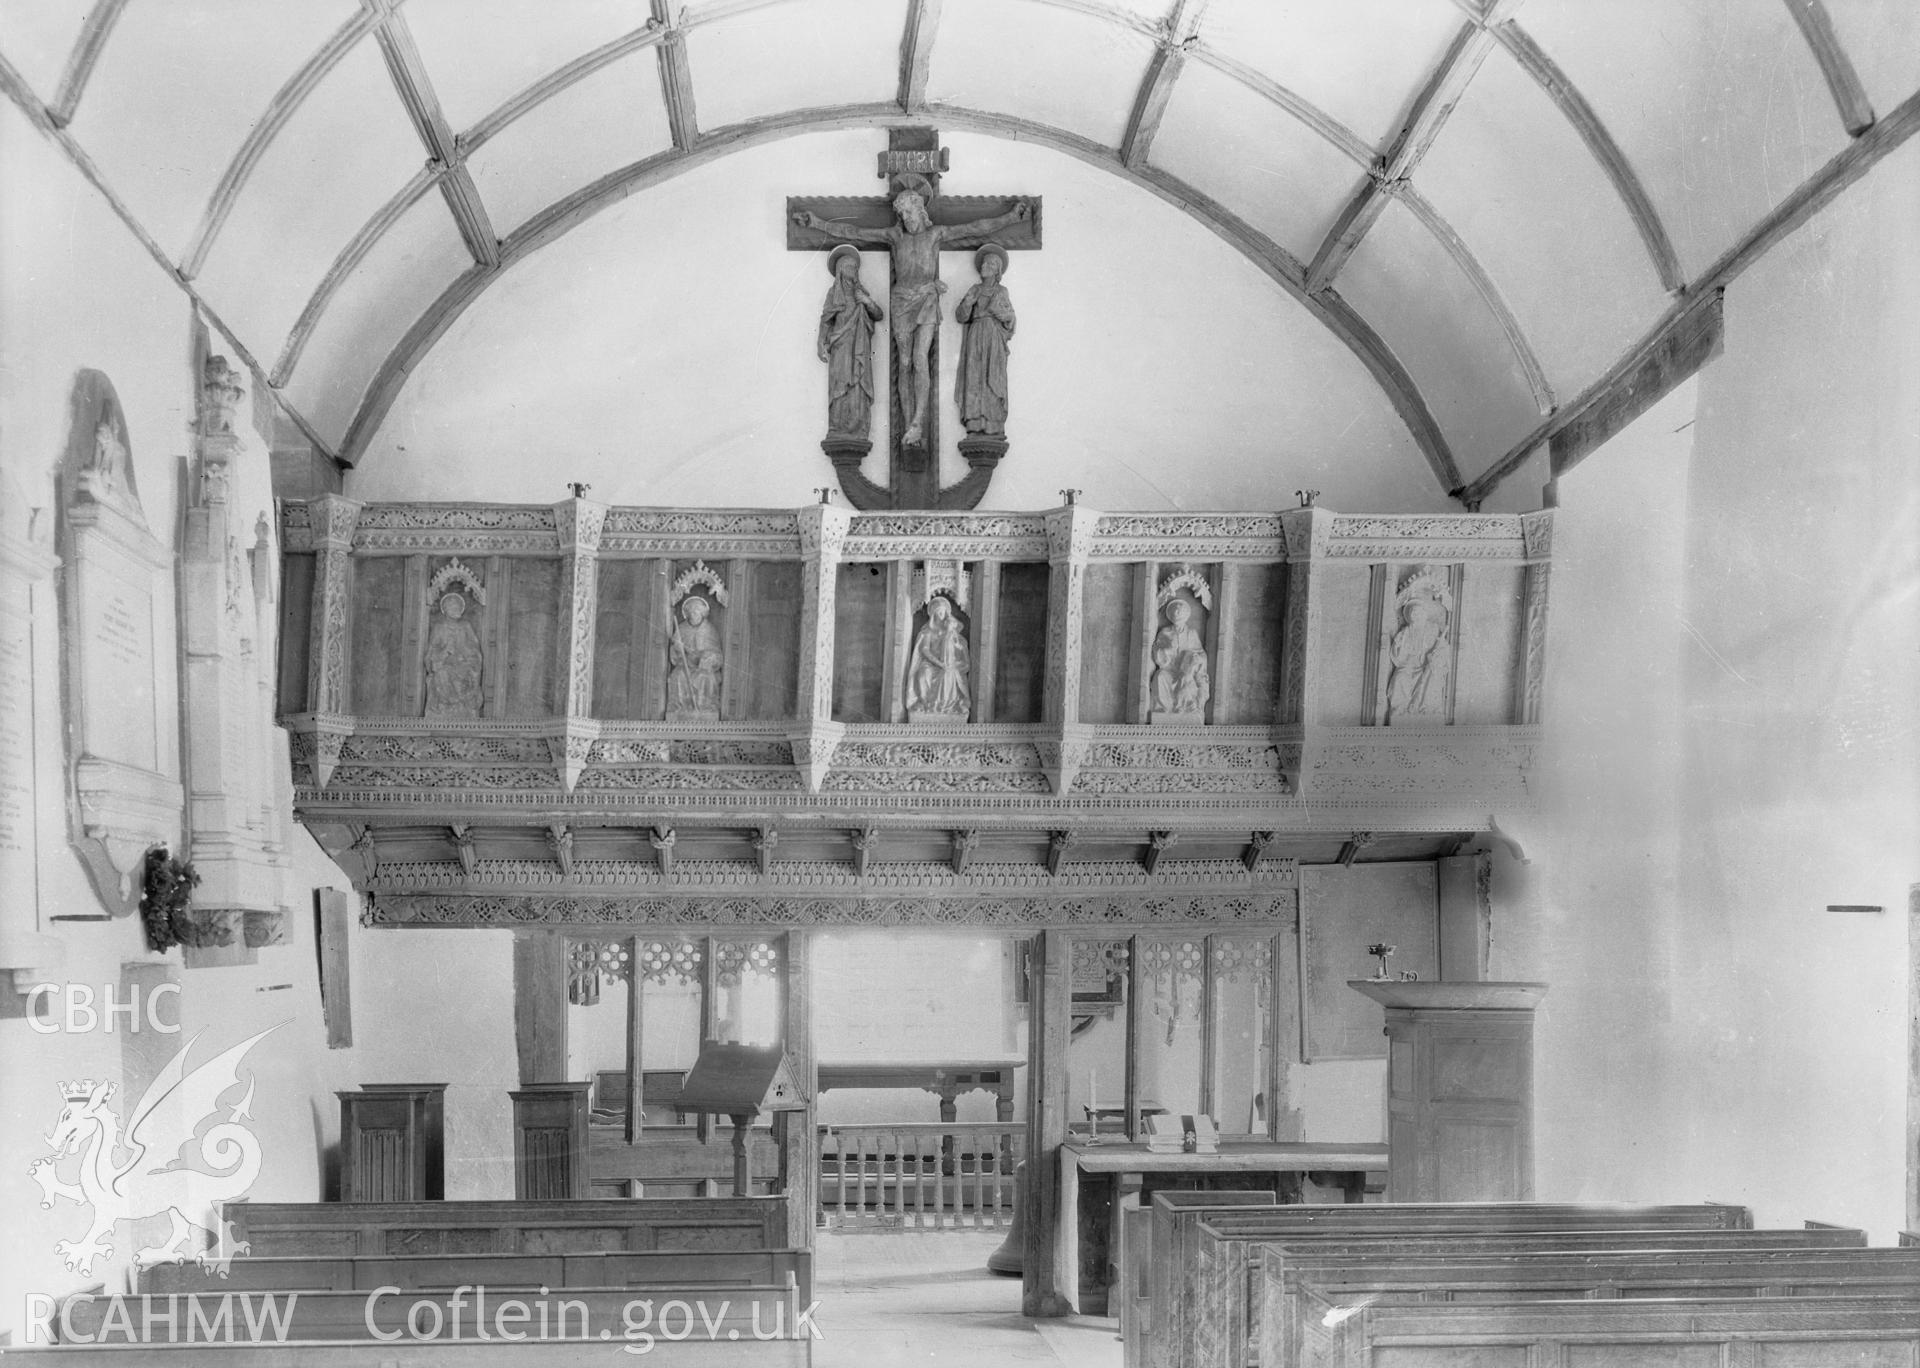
[787,129,1041,509]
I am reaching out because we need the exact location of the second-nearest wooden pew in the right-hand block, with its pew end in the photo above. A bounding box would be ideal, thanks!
[1252,1247,1920,1368]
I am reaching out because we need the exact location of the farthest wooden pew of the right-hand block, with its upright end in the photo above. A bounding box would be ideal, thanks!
[1146,1193,1753,1368]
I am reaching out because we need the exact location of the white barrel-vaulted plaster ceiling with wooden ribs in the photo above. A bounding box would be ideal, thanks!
[0,0,1920,501]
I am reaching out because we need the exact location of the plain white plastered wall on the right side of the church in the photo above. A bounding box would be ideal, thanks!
[1496,136,1920,1239]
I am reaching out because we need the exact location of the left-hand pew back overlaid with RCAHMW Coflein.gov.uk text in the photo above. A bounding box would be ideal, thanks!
[58,1282,801,1362]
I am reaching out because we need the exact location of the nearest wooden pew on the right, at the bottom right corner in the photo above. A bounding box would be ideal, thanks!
[1331,1297,1920,1368]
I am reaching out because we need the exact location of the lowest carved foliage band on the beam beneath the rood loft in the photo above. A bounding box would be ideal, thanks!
[361,888,1296,928]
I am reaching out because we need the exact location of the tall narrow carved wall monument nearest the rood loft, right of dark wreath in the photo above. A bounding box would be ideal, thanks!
[180,355,290,963]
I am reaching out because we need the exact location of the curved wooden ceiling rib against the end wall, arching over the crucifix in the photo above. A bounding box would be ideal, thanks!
[340,104,1461,492]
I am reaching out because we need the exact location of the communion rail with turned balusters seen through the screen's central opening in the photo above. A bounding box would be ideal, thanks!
[820,1120,1027,1230]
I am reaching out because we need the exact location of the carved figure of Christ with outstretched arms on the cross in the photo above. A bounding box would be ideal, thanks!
[793,190,1033,448]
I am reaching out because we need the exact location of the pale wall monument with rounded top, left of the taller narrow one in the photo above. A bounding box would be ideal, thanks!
[60,371,184,916]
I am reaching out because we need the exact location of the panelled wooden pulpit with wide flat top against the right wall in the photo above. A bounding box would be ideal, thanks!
[1348,978,1548,1201]
